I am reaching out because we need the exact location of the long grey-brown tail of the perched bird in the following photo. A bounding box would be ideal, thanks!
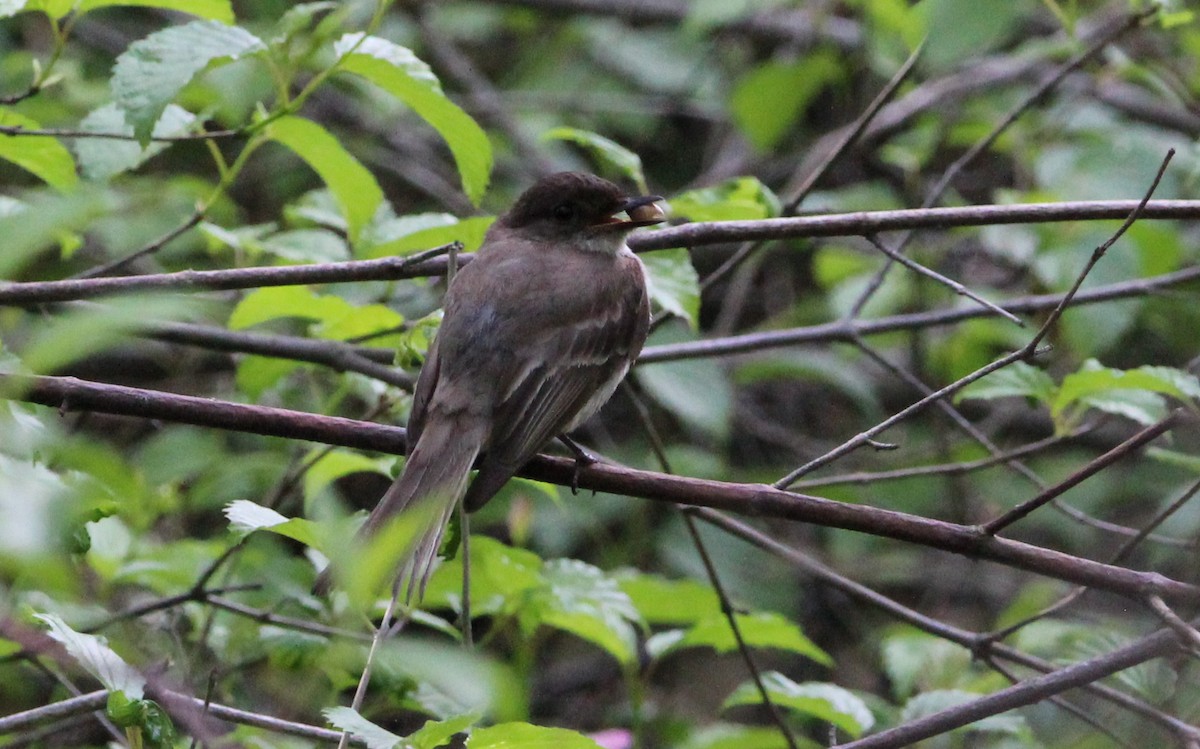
[318,419,482,603]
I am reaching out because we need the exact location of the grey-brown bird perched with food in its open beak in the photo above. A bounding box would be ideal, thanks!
[316,172,665,603]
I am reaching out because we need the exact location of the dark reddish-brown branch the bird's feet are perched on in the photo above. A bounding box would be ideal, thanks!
[9,375,1200,601]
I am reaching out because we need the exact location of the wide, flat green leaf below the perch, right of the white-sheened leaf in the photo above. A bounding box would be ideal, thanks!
[646,611,833,666]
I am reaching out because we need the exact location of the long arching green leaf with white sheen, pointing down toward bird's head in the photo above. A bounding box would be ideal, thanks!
[334,34,492,205]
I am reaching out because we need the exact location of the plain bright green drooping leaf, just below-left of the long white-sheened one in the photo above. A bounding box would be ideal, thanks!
[266,116,383,245]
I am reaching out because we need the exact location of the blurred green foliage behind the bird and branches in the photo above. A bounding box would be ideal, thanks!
[0,0,1200,748]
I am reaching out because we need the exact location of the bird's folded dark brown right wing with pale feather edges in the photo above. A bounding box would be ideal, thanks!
[464,258,649,510]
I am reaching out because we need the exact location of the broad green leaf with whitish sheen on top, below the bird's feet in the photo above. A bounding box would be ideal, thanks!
[520,559,641,666]
